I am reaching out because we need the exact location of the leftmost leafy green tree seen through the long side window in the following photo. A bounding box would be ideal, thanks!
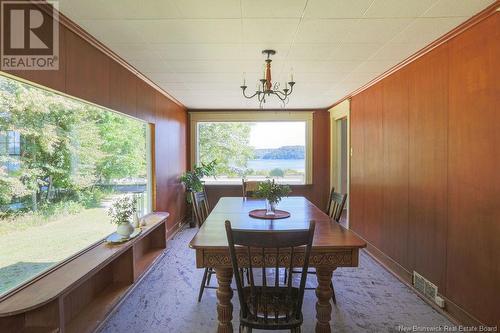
[0,78,100,208]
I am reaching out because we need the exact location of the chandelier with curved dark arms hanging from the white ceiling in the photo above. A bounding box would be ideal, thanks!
[240,50,295,109]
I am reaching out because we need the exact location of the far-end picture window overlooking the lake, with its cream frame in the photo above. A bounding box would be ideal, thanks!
[191,112,312,185]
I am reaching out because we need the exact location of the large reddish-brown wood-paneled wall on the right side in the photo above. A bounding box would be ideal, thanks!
[350,13,500,325]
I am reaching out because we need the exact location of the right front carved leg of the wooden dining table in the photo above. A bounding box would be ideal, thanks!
[316,268,335,333]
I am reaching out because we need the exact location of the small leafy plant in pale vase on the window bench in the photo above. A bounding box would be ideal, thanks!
[107,196,137,238]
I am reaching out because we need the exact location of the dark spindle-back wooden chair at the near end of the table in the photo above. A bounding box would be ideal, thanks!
[225,221,315,333]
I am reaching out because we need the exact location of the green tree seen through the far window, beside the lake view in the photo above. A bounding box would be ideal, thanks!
[198,122,253,176]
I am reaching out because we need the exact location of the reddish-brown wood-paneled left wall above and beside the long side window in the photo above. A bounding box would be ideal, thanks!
[0,24,187,233]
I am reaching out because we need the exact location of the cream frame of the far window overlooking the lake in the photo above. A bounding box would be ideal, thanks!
[189,111,314,186]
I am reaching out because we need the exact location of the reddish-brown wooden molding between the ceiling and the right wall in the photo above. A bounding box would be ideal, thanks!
[329,0,500,109]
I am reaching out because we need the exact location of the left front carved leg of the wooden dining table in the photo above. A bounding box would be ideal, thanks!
[215,268,233,333]
